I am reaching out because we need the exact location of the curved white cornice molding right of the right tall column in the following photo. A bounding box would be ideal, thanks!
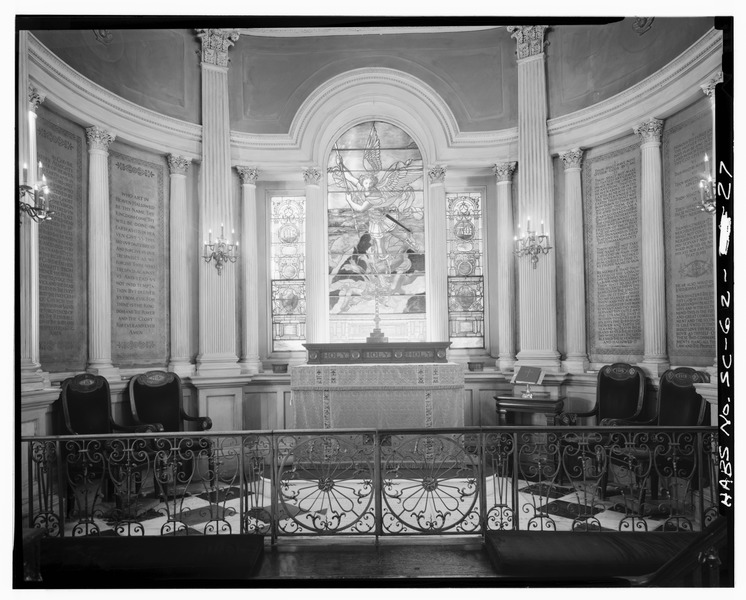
[547,29,723,154]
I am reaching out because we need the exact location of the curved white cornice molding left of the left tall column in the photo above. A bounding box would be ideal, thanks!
[28,34,202,160]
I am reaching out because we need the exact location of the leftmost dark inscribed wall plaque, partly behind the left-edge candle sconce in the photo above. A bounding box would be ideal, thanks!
[36,106,88,373]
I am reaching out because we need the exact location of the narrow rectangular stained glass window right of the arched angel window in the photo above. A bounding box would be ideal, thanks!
[446,192,484,348]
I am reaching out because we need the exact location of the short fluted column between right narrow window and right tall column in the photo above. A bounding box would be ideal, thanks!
[493,162,517,371]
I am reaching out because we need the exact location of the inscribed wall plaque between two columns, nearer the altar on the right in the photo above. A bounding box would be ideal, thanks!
[583,139,643,362]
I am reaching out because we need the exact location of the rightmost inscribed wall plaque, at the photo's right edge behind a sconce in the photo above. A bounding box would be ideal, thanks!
[663,98,716,366]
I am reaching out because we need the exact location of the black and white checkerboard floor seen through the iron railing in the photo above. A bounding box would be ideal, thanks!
[59,477,697,535]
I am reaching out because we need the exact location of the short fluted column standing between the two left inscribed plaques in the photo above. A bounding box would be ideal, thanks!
[86,126,119,379]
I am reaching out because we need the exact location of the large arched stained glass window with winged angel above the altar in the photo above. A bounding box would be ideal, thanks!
[327,121,426,342]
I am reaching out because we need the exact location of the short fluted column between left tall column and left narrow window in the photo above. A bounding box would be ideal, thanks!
[236,167,262,373]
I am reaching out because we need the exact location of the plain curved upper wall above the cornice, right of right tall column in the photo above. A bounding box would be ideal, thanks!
[546,17,714,118]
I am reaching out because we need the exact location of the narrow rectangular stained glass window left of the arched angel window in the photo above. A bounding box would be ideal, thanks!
[270,196,306,352]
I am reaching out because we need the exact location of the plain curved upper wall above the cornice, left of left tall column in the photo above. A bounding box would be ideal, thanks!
[33,29,202,123]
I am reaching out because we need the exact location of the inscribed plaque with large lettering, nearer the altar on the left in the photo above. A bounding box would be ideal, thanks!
[109,151,169,367]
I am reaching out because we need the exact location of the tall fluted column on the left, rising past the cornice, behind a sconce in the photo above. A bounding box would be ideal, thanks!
[197,29,238,375]
